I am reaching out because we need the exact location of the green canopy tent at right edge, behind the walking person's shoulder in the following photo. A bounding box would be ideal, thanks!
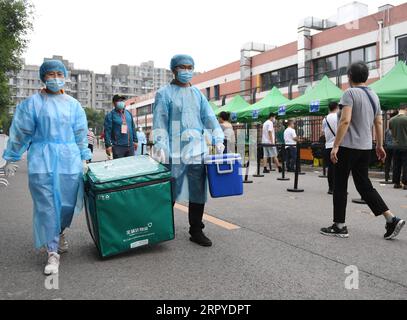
[369,61,407,110]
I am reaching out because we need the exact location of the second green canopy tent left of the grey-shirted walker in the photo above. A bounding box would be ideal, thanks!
[237,87,290,123]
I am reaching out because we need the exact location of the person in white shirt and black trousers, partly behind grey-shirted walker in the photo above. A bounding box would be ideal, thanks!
[322,102,339,194]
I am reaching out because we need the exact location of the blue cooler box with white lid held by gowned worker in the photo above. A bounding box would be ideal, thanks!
[205,154,243,198]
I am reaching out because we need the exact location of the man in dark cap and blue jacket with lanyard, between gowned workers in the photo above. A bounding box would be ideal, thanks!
[104,95,138,159]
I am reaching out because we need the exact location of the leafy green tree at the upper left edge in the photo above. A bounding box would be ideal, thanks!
[0,0,34,130]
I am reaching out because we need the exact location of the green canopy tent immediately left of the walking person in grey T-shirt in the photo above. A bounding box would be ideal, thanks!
[278,76,343,118]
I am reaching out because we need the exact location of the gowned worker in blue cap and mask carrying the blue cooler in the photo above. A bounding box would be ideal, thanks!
[153,55,225,247]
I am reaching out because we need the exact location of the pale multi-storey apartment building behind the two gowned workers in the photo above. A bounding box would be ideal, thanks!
[9,56,172,112]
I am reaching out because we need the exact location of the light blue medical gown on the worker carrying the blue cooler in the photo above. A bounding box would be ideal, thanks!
[153,84,224,204]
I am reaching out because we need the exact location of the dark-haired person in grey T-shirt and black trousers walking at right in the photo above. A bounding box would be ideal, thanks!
[321,62,405,240]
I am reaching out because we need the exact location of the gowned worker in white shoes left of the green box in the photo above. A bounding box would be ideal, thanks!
[3,60,91,275]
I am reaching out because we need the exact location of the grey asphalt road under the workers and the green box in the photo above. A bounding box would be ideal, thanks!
[0,149,407,300]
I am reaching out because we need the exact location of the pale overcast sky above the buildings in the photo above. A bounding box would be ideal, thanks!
[23,0,405,73]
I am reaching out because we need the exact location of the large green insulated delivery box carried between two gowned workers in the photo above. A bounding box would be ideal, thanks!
[84,156,175,258]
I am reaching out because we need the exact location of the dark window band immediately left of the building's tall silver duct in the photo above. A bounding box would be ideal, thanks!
[261,65,298,91]
